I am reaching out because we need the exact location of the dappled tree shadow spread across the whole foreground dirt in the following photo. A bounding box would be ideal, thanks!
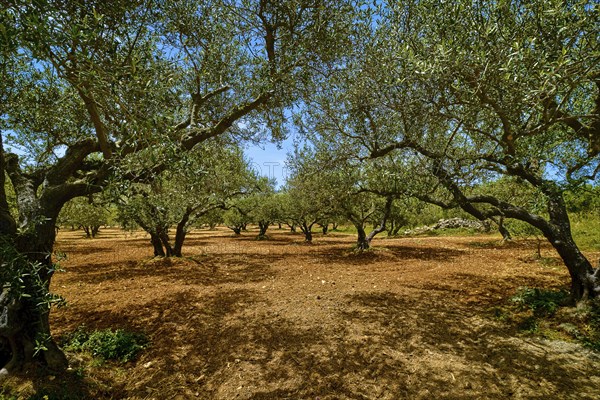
[48,282,600,400]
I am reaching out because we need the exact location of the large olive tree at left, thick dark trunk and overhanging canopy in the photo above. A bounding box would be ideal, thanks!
[0,0,356,374]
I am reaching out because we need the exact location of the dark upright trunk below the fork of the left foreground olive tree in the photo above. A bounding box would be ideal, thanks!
[0,182,68,376]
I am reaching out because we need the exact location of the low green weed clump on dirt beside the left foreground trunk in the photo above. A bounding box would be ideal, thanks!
[64,326,148,363]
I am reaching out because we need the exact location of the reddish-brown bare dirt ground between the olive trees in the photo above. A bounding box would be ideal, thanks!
[5,229,600,400]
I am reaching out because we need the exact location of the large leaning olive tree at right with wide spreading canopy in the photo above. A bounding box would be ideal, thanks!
[305,1,600,301]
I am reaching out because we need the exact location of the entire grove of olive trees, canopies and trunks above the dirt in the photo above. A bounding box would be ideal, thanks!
[0,0,600,374]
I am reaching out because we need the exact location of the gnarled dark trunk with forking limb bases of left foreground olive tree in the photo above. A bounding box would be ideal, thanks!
[0,135,105,376]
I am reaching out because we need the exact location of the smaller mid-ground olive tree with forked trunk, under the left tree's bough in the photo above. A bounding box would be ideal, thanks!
[116,140,255,257]
